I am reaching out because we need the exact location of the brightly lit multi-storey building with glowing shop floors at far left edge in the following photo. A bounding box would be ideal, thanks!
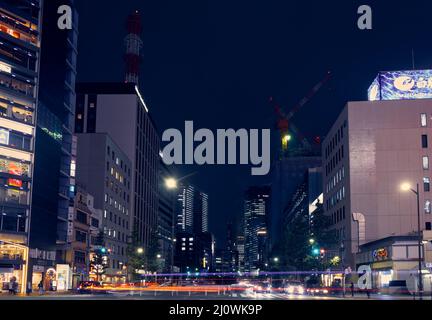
[0,0,42,292]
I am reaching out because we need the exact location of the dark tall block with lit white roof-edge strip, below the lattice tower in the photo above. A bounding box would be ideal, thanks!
[75,83,159,247]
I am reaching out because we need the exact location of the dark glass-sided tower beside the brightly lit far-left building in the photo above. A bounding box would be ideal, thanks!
[30,0,78,288]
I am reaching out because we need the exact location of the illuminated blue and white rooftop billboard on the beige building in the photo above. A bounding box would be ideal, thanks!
[368,70,432,101]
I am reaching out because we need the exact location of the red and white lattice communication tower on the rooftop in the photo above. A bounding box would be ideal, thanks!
[125,11,143,85]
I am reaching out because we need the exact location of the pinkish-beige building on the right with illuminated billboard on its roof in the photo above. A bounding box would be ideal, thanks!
[323,70,432,269]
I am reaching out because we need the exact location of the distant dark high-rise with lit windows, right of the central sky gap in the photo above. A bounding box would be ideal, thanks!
[244,186,270,271]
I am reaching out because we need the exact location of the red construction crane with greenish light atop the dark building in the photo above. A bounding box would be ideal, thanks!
[269,72,331,158]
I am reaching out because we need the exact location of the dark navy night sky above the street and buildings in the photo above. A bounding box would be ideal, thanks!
[76,0,432,246]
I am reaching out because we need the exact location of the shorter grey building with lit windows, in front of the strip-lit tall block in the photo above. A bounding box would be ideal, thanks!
[76,133,132,282]
